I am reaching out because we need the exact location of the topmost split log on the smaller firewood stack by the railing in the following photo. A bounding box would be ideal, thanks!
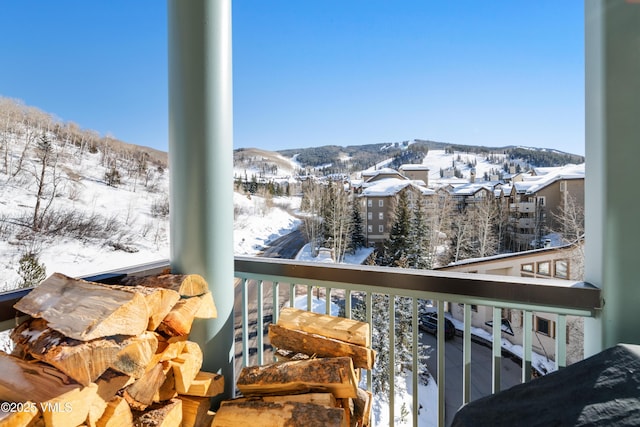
[277,307,371,347]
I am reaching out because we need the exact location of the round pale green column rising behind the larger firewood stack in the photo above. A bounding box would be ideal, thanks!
[167,0,234,407]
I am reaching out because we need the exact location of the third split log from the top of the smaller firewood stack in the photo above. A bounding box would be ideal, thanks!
[237,357,357,398]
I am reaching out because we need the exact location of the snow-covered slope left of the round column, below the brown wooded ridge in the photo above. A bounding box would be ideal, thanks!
[0,128,169,290]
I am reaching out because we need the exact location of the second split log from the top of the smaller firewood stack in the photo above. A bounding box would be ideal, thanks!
[269,324,376,369]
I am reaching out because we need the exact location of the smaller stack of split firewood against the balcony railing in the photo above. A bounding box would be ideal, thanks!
[213,308,375,427]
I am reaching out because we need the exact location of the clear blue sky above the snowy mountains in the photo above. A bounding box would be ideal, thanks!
[0,0,584,154]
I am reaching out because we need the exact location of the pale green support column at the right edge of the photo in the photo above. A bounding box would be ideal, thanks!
[585,0,640,357]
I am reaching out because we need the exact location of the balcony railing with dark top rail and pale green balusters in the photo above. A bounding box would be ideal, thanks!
[0,257,601,426]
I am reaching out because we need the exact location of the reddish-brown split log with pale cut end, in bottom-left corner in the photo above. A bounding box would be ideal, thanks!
[0,352,98,427]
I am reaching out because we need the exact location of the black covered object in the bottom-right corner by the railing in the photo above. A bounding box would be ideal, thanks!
[452,344,640,427]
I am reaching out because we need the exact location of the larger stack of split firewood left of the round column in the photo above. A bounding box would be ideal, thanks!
[0,274,224,427]
